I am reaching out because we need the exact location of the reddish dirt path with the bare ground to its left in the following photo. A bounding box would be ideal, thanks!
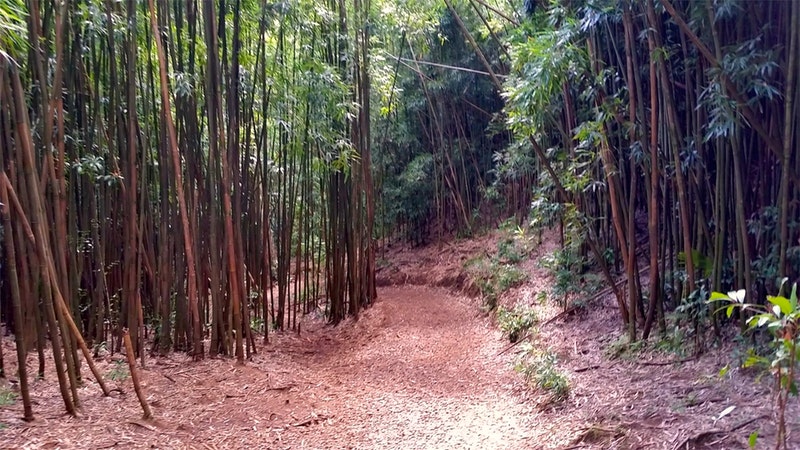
[0,286,536,449]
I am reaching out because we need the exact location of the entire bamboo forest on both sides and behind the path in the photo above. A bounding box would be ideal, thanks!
[0,0,800,418]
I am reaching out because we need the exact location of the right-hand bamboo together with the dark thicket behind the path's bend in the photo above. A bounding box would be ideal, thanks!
[376,0,800,351]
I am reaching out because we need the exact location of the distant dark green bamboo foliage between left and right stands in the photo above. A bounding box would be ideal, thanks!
[370,1,509,243]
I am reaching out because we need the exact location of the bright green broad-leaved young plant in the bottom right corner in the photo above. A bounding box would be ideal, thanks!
[708,279,800,448]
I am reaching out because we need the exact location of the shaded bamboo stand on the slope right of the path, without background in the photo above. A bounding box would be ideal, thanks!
[504,0,800,349]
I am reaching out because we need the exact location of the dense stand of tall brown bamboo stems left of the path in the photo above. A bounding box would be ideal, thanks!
[0,0,376,419]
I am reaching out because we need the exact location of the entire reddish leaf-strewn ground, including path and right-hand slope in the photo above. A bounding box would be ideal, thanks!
[0,230,800,450]
